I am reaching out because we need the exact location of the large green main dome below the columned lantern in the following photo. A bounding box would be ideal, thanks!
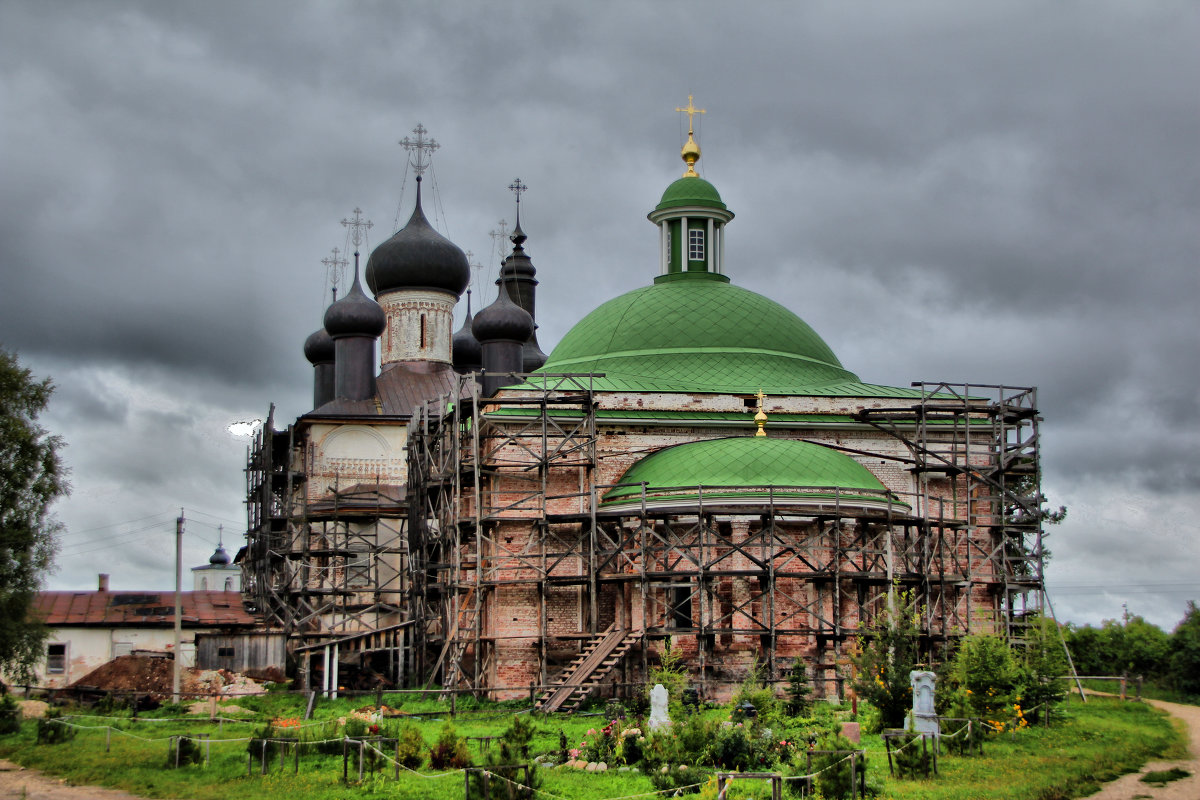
[538,272,858,395]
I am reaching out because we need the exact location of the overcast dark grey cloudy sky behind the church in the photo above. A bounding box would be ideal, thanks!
[0,0,1200,626]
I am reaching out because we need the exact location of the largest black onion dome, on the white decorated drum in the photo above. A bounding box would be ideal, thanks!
[366,184,470,297]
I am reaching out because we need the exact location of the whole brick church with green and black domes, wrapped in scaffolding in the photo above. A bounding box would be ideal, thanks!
[241,106,1042,710]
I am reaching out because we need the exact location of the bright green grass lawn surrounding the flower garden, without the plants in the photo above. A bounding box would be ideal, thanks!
[0,694,1186,800]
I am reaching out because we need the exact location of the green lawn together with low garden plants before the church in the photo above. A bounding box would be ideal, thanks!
[0,681,1178,800]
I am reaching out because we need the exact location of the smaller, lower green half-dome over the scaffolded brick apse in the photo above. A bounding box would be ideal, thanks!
[601,437,907,509]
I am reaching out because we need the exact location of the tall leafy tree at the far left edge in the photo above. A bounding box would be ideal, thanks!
[0,349,67,680]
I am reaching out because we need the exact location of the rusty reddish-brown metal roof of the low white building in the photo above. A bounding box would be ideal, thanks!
[34,591,259,627]
